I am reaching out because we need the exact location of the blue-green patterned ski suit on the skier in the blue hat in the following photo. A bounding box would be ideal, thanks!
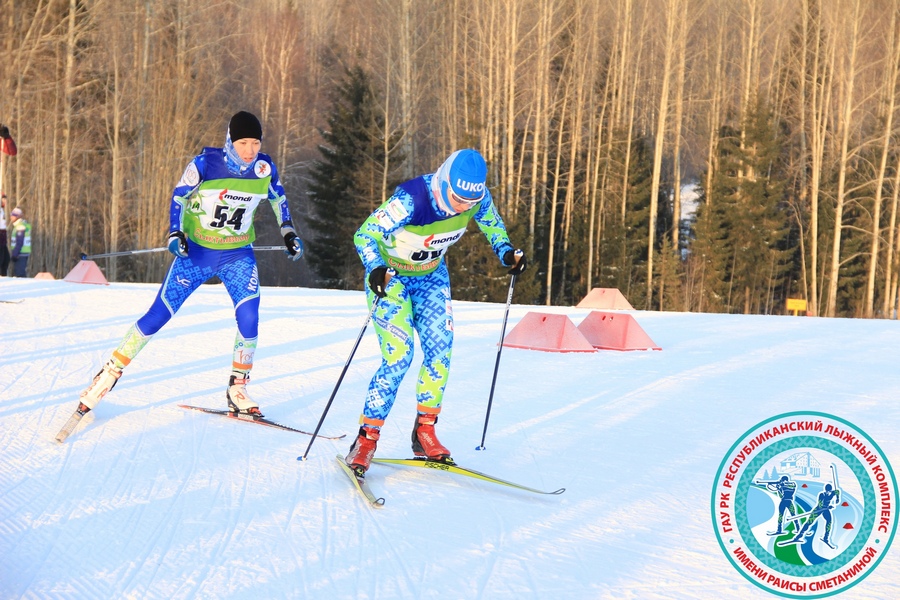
[354,174,513,428]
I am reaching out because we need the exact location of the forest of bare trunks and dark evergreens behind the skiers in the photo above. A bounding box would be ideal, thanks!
[0,0,900,318]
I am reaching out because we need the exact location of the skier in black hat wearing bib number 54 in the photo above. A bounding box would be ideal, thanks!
[79,111,303,417]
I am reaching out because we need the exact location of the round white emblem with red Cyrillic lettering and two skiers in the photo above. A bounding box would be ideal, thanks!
[712,412,897,598]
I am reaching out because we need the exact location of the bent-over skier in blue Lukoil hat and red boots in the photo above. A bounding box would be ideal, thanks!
[345,149,526,475]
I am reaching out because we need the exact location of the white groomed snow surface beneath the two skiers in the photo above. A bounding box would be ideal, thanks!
[0,279,900,600]
